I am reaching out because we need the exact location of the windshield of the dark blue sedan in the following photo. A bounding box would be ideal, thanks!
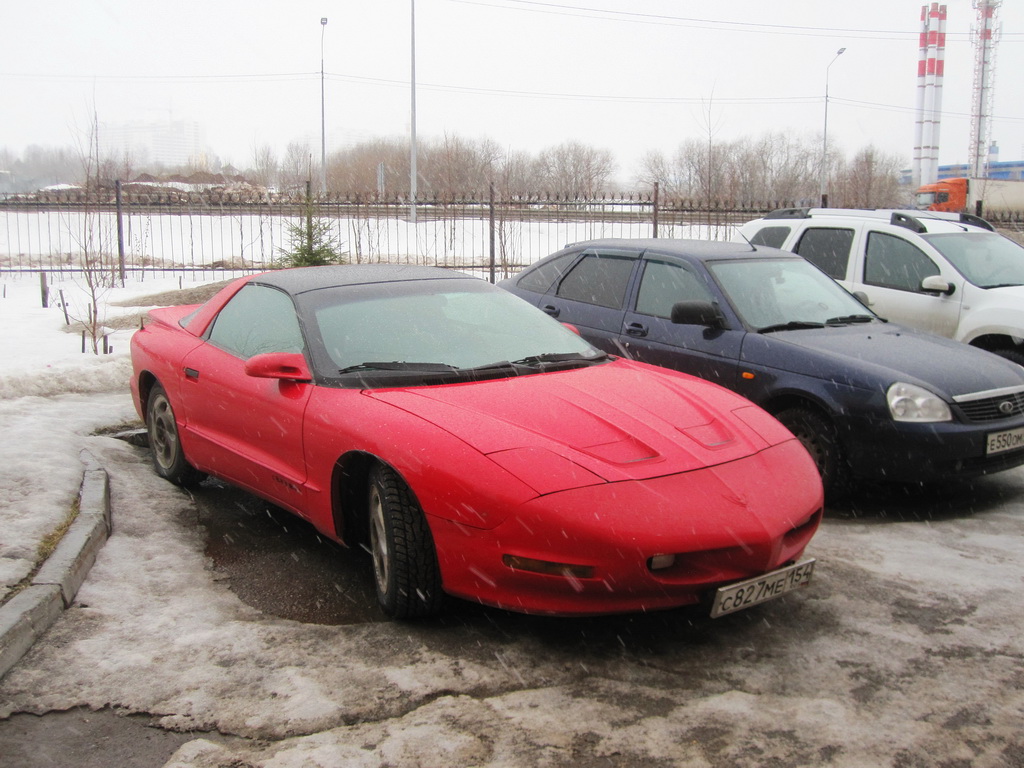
[708,258,876,332]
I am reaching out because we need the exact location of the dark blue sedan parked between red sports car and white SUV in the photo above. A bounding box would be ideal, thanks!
[500,240,1024,494]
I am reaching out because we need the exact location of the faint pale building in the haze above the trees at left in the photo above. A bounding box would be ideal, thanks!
[98,120,208,168]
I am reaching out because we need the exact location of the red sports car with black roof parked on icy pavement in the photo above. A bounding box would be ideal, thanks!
[132,265,822,617]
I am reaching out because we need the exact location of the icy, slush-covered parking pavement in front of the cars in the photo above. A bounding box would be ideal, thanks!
[0,438,1024,768]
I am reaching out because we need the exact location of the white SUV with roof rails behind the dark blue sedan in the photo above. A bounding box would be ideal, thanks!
[739,208,1024,365]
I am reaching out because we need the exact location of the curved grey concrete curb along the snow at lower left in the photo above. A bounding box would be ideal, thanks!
[0,456,112,678]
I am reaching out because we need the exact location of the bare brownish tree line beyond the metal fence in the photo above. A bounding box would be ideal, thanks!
[0,132,912,208]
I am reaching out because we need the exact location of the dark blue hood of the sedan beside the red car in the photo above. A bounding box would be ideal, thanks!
[740,323,1024,398]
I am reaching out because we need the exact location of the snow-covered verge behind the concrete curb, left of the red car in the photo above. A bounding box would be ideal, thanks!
[0,274,201,595]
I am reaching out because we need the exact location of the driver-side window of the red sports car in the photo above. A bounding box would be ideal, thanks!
[208,285,303,359]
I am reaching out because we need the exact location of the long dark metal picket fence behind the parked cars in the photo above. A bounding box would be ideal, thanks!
[0,188,781,280]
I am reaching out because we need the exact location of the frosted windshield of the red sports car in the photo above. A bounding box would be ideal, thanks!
[303,280,605,380]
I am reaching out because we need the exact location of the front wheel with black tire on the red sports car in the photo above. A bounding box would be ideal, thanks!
[368,464,443,618]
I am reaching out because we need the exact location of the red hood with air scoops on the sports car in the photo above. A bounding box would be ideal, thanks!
[366,360,795,493]
